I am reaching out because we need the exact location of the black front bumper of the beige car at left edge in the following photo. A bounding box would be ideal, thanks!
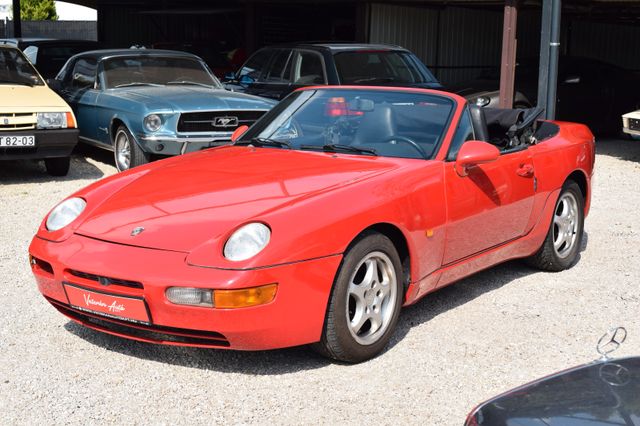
[0,129,78,160]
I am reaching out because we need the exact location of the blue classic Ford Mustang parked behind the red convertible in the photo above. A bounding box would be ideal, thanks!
[50,49,275,171]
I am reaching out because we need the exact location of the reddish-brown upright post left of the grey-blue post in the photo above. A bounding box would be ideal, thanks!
[499,0,518,108]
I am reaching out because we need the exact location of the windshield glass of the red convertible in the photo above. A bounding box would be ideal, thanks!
[238,89,455,158]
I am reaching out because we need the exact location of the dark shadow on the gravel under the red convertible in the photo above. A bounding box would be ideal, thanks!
[64,231,589,375]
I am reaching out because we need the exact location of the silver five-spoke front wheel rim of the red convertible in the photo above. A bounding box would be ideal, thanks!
[345,251,398,345]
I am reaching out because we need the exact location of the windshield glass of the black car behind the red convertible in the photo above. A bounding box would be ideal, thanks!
[334,50,437,86]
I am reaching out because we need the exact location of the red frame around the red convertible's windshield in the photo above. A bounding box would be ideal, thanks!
[235,86,460,160]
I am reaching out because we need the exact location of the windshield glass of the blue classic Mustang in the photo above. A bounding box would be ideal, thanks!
[103,56,222,89]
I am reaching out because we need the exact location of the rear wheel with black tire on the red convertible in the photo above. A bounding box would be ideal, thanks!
[527,180,584,272]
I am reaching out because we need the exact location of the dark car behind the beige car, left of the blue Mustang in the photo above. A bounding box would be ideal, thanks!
[0,38,100,79]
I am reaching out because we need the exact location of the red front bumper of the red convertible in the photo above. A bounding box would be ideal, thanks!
[29,235,341,350]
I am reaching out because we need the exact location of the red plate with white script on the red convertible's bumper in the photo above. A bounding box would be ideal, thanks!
[64,283,150,324]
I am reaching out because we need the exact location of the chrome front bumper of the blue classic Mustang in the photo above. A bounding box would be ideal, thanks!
[138,132,232,155]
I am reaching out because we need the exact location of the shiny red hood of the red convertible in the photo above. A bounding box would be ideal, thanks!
[75,146,397,252]
